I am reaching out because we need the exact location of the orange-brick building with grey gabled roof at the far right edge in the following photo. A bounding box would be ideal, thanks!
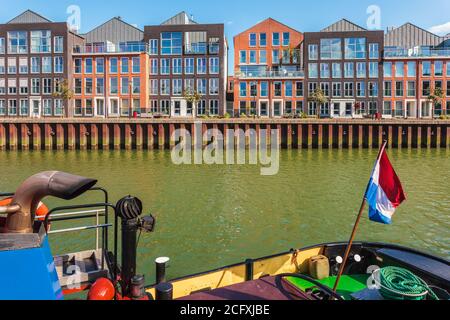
[383,23,450,118]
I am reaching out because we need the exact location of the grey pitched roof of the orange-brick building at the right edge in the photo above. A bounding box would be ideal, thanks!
[384,22,444,48]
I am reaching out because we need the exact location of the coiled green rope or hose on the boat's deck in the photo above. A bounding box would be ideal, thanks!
[379,267,439,300]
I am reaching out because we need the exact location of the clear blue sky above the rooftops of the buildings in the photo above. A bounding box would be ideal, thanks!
[0,0,450,72]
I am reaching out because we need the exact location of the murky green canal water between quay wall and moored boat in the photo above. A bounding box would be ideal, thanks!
[0,149,450,282]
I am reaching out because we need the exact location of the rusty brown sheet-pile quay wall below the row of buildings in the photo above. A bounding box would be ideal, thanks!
[0,118,450,151]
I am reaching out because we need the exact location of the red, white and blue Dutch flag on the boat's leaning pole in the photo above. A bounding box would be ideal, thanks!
[365,143,406,224]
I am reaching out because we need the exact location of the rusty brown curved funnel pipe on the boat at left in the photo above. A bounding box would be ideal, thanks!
[5,171,97,233]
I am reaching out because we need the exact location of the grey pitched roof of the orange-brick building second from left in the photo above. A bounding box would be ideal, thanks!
[83,17,144,44]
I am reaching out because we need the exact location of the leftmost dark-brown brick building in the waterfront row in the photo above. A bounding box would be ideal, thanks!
[0,10,83,117]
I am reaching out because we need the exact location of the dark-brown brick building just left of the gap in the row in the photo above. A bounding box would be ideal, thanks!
[144,12,228,117]
